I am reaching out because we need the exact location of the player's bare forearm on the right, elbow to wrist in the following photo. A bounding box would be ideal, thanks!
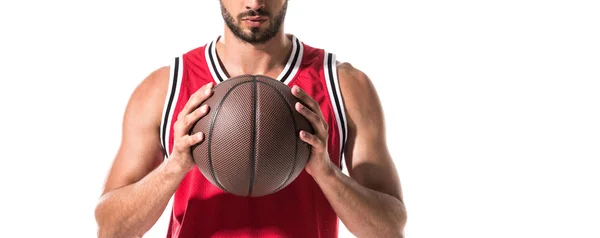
[315,168,406,237]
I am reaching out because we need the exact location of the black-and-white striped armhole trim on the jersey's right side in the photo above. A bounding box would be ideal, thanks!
[323,52,348,171]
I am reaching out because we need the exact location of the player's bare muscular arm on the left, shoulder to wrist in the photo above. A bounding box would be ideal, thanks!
[95,67,187,237]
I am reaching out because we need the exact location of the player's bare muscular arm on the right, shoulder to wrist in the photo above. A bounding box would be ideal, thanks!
[313,63,406,237]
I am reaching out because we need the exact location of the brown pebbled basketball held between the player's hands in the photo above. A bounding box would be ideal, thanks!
[191,75,313,197]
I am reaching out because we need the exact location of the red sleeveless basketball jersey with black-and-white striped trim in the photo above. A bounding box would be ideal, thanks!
[160,35,347,238]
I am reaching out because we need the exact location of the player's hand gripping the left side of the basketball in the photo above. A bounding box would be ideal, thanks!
[169,82,213,173]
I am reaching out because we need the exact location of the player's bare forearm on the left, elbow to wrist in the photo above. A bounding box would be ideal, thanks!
[96,160,186,237]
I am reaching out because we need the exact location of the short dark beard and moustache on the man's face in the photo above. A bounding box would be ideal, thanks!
[221,1,287,44]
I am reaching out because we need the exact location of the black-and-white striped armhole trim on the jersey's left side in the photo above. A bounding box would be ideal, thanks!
[160,57,183,159]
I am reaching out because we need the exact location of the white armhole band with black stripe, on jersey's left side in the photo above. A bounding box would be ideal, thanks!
[161,56,183,158]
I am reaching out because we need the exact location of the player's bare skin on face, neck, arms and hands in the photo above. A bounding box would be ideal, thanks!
[95,0,406,237]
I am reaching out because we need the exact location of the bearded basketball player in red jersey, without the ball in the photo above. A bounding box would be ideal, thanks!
[95,0,406,238]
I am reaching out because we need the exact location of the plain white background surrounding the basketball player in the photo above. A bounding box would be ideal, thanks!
[0,0,600,238]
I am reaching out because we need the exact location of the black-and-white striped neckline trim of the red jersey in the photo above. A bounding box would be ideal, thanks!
[204,35,304,84]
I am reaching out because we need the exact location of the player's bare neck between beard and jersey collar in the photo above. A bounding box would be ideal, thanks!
[216,26,292,78]
